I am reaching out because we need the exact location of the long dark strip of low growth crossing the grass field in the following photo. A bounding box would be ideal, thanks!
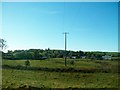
[2,65,118,73]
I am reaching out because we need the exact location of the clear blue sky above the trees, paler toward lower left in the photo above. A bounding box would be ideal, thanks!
[2,2,118,51]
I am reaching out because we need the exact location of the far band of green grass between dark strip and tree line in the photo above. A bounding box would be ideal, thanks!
[3,58,118,72]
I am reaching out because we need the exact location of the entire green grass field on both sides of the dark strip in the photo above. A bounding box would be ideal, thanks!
[2,59,119,88]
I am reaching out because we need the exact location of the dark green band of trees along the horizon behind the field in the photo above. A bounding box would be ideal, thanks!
[2,48,120,60]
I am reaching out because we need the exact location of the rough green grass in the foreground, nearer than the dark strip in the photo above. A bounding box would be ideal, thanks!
[3,69,119,88]
